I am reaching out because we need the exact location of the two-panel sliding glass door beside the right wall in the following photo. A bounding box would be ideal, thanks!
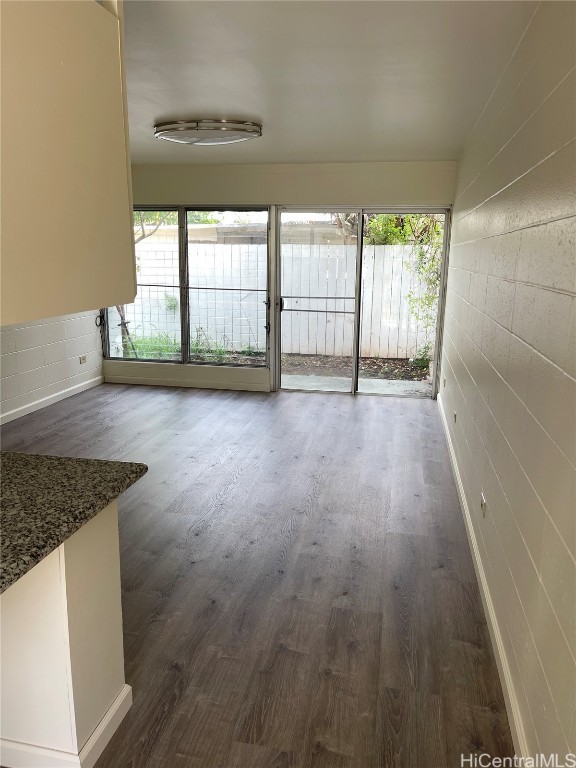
[278,209,447,397]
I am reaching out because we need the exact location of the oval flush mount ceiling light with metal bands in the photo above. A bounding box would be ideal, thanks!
[154,120,262,147]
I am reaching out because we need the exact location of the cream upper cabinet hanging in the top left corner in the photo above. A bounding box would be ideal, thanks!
[0,0,136,325]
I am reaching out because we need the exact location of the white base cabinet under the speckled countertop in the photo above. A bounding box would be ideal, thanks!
[0,501,132,768]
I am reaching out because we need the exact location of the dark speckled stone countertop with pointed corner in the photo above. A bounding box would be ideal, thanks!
[0,452,148,592]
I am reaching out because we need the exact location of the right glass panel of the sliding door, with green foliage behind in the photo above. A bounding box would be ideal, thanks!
[357,213,445,397]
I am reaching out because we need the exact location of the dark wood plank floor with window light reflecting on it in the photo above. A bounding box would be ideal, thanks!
[2,385,513,768]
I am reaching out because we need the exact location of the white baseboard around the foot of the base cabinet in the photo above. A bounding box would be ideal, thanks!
[0,685,132,768]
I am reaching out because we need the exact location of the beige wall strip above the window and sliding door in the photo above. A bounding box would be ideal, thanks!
[132,160,456,206]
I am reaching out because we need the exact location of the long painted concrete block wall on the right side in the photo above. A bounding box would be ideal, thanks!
[440,2,576,754]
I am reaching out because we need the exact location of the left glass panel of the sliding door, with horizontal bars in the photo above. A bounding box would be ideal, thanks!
[280,211,358,392]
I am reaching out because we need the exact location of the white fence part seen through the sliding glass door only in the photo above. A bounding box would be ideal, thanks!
[282,245,426,358]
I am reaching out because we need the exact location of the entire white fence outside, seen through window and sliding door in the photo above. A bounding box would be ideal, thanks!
[110,236,427,358]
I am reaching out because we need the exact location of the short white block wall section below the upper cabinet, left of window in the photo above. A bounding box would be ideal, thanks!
[0,311,103,423]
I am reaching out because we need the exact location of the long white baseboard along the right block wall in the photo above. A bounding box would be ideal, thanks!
[437,397,530,758]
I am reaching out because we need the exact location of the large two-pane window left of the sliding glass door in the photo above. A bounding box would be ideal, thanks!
[107,209,268,366]
